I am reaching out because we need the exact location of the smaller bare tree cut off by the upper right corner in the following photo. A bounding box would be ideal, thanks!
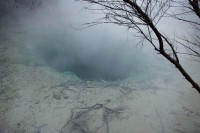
[168,0,200,62]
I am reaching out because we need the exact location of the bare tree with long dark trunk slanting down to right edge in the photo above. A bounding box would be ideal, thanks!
[82,0,200,93]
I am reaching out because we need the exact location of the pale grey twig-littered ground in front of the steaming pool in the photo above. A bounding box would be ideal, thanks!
[0,23,200,133]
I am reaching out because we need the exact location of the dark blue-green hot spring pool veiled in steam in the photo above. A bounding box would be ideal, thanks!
[32,29,146,80]
